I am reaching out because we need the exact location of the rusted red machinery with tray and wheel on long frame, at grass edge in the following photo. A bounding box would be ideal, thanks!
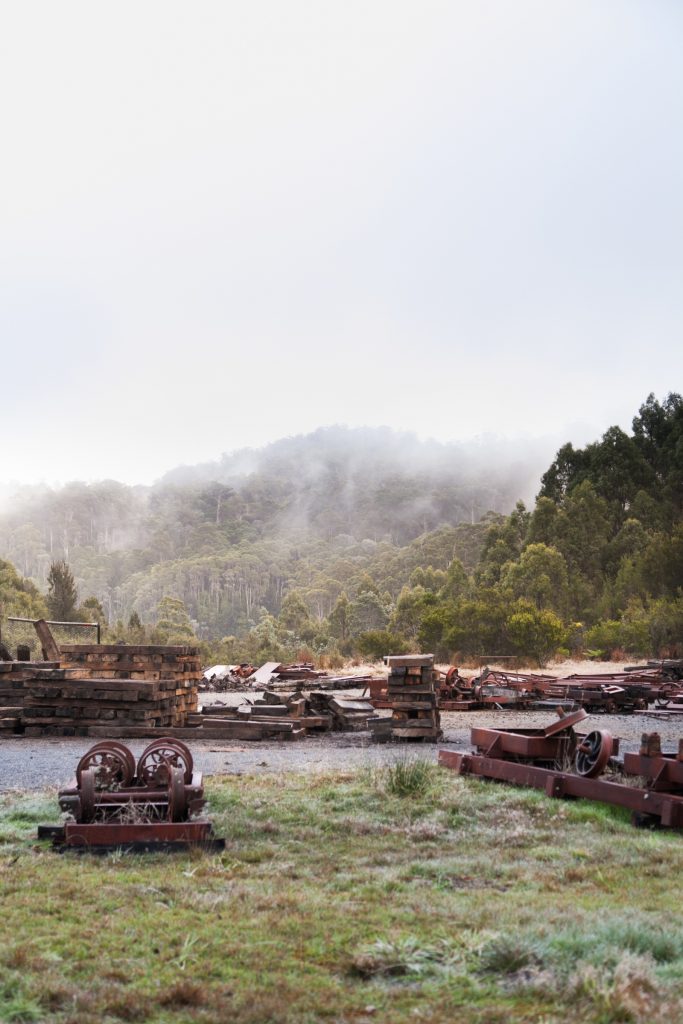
[438,709,683,828]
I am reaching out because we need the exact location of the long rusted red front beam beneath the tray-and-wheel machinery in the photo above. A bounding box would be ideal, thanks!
[438,751,683,828]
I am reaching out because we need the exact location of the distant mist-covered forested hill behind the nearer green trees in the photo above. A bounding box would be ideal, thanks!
[0,428,541,639]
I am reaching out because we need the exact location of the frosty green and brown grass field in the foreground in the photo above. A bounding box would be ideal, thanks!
[0,760,683,1024]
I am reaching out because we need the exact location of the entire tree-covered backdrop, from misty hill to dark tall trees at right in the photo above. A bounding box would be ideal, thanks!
[0,403,683,662]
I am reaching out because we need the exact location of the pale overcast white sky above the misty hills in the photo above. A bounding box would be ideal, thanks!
[0,0,683,483]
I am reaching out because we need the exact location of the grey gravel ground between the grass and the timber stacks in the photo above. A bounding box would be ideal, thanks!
[0,693,683,792]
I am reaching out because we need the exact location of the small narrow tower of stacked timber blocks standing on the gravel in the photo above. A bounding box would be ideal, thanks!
[370,654,442,742]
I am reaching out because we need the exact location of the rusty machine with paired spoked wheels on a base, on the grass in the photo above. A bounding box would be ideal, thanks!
[38,737,224,852]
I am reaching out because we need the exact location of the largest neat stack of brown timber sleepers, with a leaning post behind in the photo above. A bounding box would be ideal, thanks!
[0,620,201,738]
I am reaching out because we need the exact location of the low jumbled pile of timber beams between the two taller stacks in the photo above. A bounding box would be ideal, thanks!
[187,690,375,740]
